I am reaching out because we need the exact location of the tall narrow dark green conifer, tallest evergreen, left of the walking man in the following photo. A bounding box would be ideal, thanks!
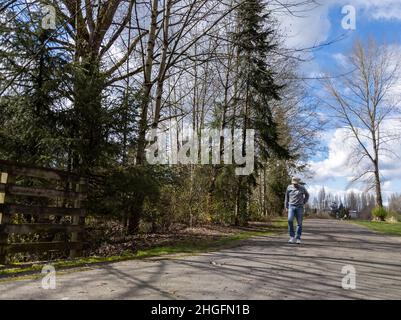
[233,0,288,224]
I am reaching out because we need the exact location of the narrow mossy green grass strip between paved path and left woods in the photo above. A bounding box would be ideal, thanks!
[0,219,287,280]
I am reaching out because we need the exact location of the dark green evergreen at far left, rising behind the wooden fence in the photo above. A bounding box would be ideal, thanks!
[0,10,67,165]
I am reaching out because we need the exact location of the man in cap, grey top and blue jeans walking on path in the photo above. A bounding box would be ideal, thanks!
[285,177,309,244]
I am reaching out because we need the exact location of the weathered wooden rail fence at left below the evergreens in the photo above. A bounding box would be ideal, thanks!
[0,160,86,264]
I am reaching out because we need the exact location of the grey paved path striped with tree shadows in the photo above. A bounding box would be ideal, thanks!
[0,220,401,299]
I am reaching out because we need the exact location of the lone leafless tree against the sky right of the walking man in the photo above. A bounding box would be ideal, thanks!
[325,40,399,207]
